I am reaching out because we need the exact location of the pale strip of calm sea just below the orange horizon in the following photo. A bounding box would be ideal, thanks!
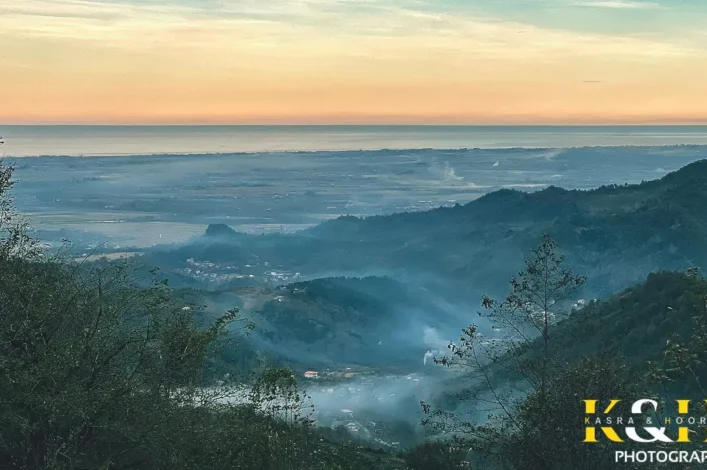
[0,126,707,157]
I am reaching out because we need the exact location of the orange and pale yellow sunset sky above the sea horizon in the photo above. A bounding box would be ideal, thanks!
[0,0,707,124]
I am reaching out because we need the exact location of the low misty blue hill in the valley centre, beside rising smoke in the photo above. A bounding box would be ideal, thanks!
[195,277,462,368]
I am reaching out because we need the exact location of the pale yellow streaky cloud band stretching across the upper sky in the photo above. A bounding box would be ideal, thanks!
[0,0,704,61]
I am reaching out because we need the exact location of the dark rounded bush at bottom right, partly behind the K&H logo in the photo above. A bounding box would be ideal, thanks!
[471,358,650,470]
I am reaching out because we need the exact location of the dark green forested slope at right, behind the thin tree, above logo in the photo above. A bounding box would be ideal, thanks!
[442,271,707,405]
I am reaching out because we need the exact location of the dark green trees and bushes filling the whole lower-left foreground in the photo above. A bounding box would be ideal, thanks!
[0,162,400,470]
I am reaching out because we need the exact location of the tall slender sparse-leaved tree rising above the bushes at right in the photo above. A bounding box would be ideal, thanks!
[436,235,586,417]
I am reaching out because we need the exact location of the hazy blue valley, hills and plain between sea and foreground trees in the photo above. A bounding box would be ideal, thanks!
[6,146,707,447]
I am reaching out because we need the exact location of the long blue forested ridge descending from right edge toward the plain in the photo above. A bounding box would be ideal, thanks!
[158,160,707,298]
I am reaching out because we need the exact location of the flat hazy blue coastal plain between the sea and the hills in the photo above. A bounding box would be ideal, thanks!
[6,145,707,247]
